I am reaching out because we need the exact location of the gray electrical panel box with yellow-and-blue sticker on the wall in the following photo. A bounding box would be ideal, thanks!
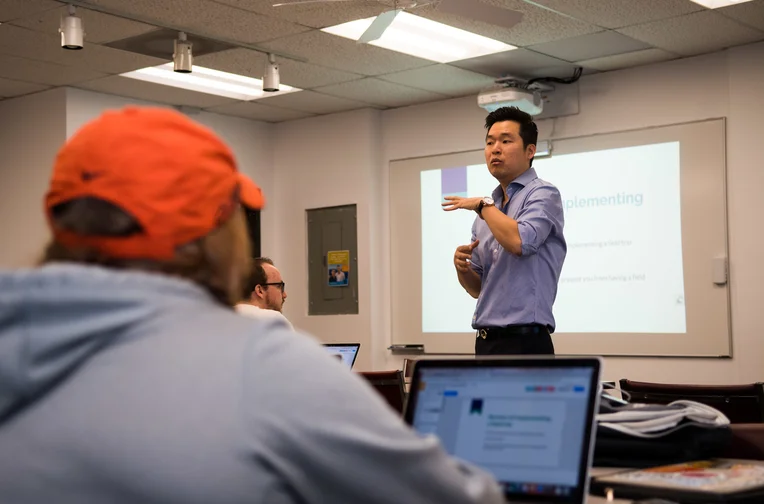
[307,205,358,315]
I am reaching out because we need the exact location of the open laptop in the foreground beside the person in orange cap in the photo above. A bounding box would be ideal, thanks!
[405,357,601,504]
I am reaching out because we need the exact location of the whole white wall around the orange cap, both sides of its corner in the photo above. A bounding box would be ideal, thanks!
[0,88,277,267]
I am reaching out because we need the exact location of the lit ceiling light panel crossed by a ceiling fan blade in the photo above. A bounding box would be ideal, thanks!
[321,12,517,63]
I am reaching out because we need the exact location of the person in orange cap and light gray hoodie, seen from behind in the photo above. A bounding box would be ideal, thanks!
[0,107,503,504]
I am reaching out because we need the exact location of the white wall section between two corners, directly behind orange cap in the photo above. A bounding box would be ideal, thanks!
[66,88,276,254]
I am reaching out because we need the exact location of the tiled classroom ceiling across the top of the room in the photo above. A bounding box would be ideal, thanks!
[0,0,764,122]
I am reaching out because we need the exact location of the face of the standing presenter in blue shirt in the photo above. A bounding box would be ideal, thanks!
[485,121,536,183]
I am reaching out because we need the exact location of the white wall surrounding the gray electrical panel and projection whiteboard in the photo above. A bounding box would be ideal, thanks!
[275,44,764,383]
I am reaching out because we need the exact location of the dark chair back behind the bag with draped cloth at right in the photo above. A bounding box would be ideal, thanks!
[620,378,764,424]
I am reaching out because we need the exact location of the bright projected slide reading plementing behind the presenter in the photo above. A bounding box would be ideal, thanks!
[421,142,686,333]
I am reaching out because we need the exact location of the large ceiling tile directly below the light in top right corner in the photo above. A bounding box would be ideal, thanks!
[618,10,764,56]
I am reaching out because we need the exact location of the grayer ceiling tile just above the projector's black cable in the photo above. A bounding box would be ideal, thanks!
[528,30,650,61]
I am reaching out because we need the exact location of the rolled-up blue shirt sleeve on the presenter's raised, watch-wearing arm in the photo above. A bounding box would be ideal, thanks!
[516,186,564,256]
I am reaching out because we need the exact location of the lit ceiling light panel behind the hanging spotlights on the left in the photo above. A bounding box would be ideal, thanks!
[122,63,302,101]
